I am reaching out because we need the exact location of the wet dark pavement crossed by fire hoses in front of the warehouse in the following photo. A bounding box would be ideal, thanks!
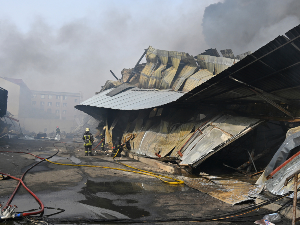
[0,140,291,224]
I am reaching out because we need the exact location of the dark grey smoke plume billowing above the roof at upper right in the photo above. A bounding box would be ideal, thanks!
[202,0,300,54]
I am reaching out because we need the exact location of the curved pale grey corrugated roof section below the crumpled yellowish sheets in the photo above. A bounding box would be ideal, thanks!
[80,88,184,110]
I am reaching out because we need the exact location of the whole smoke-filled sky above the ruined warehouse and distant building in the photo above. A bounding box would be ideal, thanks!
[0,0,300,99]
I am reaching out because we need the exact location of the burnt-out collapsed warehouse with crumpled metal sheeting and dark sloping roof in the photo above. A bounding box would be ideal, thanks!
[76,23,300,216]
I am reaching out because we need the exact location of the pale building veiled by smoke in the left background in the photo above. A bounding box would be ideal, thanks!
[0,77,83,133]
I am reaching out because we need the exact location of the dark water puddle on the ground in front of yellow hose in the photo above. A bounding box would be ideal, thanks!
[80,180,190,219]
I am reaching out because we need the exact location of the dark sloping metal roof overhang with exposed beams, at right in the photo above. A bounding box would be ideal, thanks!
[183,26,300,112]
